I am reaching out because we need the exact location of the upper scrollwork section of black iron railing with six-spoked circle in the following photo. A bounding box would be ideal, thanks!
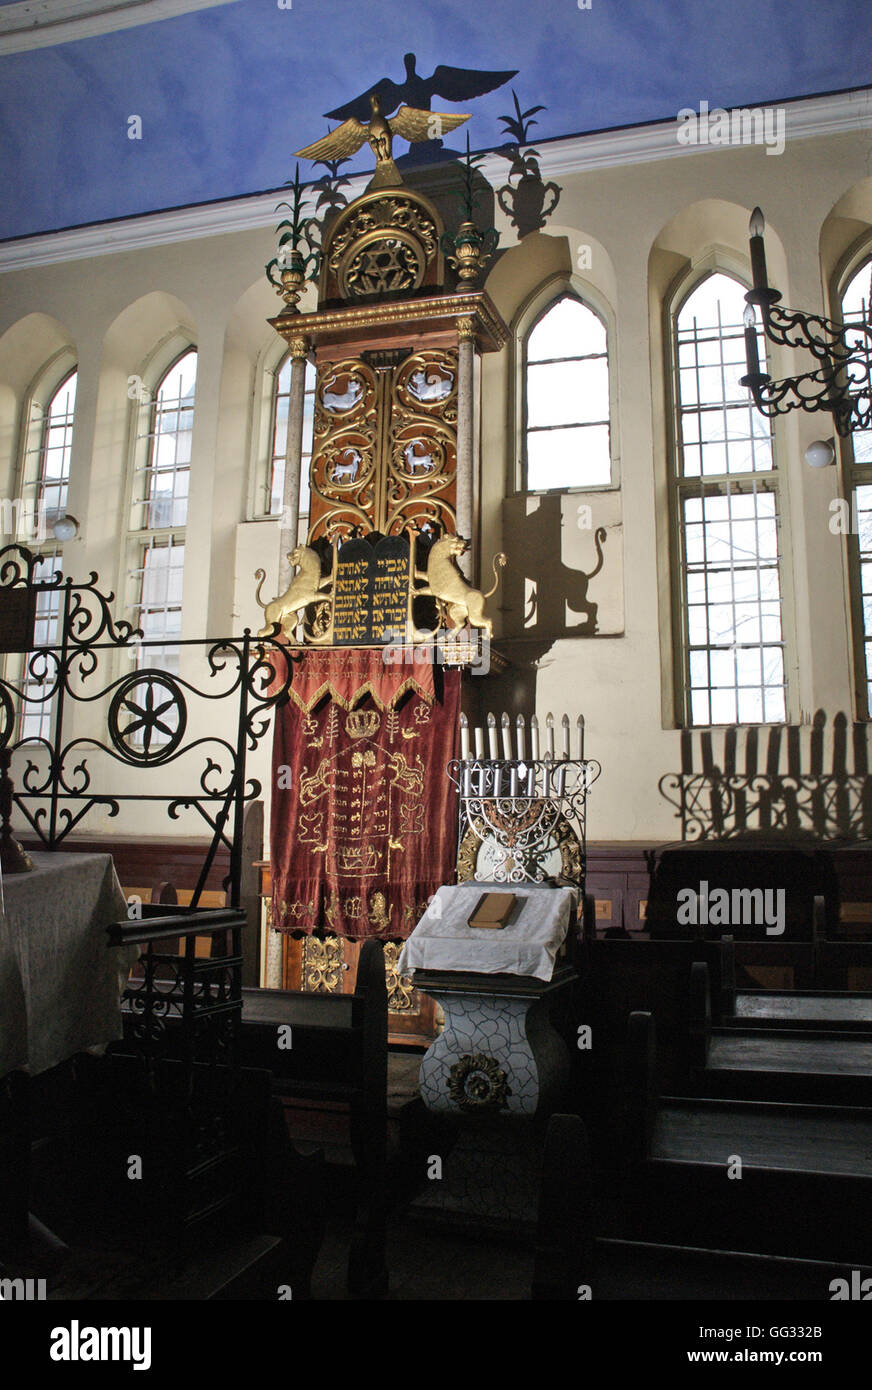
[0,545,293,908]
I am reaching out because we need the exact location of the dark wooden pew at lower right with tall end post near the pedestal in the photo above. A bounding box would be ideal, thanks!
[622,1012,872,1262]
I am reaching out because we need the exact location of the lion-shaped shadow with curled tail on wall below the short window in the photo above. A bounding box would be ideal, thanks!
[499,495,608,639]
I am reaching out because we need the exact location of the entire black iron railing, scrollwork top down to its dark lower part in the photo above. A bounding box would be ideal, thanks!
[0,545,301,1241]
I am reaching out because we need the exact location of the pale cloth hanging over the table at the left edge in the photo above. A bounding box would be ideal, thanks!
[0,852,136,1076]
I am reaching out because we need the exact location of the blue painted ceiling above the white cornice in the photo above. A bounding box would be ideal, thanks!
[0,0,872,238]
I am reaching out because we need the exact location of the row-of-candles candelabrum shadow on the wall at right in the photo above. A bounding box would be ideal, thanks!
[658,710,872,841]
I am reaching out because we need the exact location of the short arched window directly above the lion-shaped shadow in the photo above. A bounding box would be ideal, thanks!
[523,295,612,492]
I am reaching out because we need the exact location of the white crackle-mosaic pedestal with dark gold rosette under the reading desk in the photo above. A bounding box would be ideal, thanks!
[414,967,574,1225]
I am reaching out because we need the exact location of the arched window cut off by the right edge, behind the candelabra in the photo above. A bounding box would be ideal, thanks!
[841,256,872,719]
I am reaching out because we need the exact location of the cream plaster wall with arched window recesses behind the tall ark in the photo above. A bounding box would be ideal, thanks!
[0,119,872,840]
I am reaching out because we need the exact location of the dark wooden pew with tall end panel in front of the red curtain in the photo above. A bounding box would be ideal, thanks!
[239,941,388,1295]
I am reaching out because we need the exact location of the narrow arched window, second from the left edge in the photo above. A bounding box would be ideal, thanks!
[131,348,197,671]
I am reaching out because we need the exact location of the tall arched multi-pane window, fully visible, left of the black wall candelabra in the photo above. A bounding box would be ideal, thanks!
[672,272,787,724]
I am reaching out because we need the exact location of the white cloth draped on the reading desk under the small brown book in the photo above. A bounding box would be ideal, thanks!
[399,883,577,980]
